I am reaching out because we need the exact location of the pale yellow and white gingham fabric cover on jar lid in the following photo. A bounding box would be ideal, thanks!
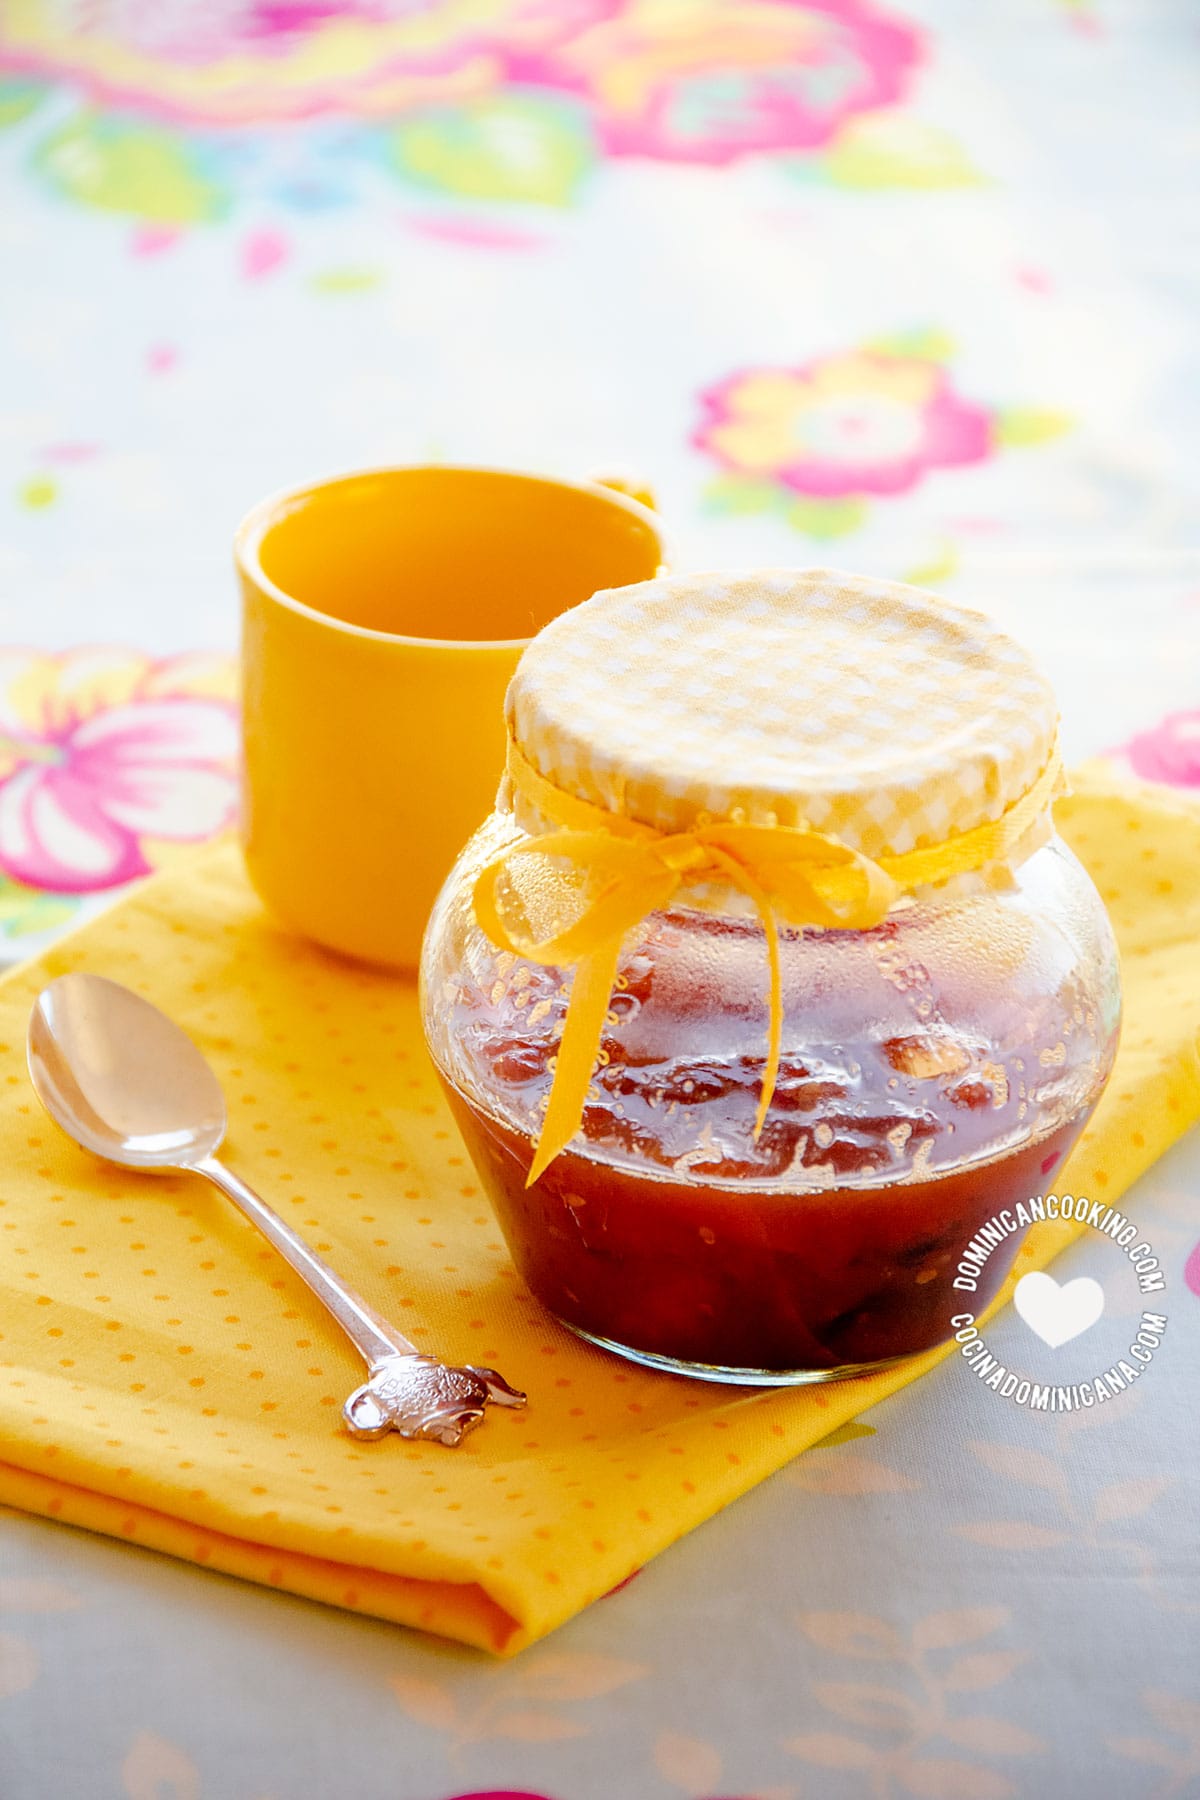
[507,569,1058,857]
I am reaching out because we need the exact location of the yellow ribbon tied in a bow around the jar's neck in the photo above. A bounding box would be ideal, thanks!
[475,740,1061,1186]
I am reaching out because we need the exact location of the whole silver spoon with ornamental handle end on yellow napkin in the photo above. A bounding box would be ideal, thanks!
[29,974,525,1445]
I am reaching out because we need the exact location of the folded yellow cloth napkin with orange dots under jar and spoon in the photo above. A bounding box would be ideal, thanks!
[0,776,1200,1652]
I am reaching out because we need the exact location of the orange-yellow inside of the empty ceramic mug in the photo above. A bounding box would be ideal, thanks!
[239,466,662,643]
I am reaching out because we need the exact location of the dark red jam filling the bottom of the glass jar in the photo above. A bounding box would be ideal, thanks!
[450,1089,1079,1375]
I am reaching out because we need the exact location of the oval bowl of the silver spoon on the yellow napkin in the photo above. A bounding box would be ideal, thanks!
[29,972,227,1170]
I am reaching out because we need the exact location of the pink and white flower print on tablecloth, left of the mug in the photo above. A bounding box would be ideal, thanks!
[0,650,237,893]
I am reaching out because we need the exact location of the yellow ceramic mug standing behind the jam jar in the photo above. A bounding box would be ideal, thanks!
[236,466,662,968]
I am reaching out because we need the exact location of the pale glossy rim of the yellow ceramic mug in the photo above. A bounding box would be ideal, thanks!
[234,463,667,650]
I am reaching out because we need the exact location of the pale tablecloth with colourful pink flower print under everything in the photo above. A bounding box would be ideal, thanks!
[0,0,1200,1800]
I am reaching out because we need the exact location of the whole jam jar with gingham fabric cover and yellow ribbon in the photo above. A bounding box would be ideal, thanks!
[421,571,1119,1384]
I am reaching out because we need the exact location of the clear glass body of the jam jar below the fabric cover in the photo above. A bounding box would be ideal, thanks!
[423,576,1119,1384]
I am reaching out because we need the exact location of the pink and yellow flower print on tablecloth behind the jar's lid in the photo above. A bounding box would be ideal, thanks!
[694,349,993,499]
